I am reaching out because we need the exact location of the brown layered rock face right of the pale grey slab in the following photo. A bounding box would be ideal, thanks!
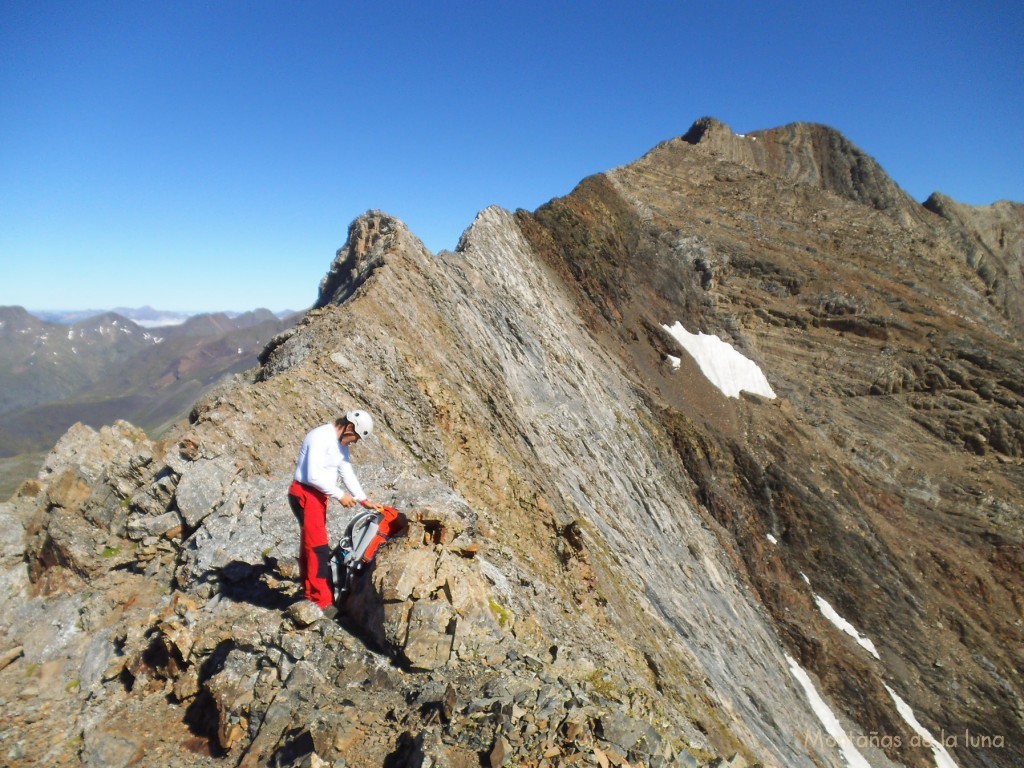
[519,121,1024,765]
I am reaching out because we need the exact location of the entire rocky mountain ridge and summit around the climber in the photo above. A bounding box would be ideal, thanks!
[0,119,1024,768]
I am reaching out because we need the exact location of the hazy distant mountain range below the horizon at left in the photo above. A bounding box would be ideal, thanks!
[0,306,301,487]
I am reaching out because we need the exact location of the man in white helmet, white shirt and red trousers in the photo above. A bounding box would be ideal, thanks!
[288,411,374,609]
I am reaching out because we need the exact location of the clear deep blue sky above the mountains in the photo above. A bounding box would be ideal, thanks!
[0,0,1024,311]
